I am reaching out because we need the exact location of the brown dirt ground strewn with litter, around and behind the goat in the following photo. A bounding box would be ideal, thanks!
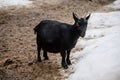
[0,0,114,80]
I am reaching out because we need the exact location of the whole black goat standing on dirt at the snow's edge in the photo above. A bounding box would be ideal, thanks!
[34,13,90,69]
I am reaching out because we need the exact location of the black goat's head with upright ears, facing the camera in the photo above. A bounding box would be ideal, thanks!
[73,13,91,37]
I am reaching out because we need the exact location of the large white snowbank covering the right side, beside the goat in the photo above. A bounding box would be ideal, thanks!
[68,0,120,80]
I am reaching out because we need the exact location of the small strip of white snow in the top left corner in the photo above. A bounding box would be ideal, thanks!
[0,0,31,7]
